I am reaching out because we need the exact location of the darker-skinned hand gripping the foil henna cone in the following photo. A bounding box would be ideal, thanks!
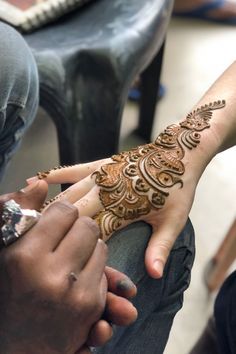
[0,181,137,354]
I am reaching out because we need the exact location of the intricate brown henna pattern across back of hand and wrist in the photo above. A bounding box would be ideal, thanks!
[94,100,225,240]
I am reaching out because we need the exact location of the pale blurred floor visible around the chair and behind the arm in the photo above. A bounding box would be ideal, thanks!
[1,14,236,354]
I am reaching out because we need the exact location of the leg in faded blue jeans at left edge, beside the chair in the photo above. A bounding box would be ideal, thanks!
[0,22,38,179]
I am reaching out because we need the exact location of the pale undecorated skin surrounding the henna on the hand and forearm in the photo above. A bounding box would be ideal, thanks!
[28,63,236,278]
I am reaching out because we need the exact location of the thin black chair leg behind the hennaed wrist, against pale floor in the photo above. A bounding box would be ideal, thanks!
[136,43,165,142]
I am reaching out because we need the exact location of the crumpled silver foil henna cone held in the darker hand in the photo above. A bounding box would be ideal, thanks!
[1,199,41,246]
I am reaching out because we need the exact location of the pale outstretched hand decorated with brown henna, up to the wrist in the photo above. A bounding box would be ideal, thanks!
[28,101,225,278]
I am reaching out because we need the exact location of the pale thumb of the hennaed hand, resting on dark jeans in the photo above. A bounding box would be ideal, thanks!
[145,220,184,279]
